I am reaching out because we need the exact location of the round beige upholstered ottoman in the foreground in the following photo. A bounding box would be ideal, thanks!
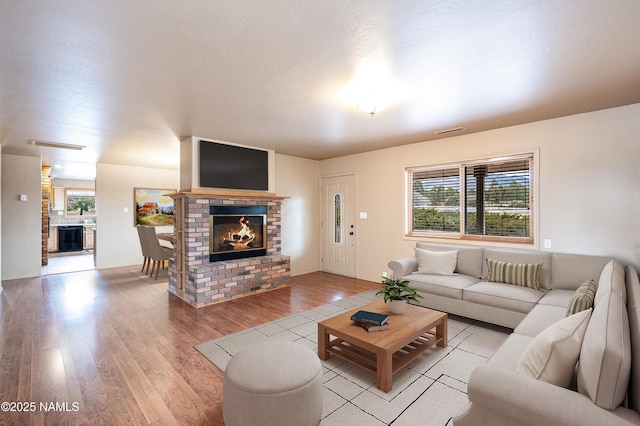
[222,340,322,426]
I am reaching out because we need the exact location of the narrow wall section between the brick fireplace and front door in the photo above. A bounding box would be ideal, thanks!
[275,154,320,276]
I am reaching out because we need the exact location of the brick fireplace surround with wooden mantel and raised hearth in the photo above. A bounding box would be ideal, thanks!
[169,189,291,307]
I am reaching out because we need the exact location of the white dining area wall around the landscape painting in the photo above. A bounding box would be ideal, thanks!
[96,164,180,269]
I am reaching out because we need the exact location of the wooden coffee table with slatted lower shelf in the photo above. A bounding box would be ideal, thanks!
[318,300,447,392]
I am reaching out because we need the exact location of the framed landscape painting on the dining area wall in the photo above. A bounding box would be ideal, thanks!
[133,188,177,226]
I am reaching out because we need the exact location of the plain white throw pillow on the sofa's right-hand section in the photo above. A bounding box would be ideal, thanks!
[516,309,592,388]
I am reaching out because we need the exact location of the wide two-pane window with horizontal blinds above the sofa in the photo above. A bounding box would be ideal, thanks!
[406,154,534,243]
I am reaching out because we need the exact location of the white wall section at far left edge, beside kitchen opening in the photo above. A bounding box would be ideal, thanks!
[1,154,42,280]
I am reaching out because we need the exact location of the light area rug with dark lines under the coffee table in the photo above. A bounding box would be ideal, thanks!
[195,290,508,426]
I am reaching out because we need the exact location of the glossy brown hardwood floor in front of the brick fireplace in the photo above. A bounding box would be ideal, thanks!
[0,267,379,425]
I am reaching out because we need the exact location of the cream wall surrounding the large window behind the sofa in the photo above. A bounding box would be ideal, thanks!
[320,104,640,281]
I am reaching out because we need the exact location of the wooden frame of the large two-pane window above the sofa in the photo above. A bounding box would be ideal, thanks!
[404,150,538,245]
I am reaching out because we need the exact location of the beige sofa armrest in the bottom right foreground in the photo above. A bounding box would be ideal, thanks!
[453,365,640,426]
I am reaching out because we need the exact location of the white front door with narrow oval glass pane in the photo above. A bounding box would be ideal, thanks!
[322,175,356,277]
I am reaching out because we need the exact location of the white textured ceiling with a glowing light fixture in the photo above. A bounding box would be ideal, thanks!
[0,0,640,177]
